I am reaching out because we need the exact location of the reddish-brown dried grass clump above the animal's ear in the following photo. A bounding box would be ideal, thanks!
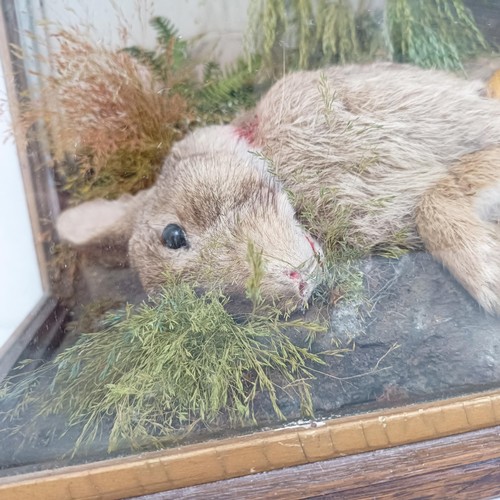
[22,29,190,199]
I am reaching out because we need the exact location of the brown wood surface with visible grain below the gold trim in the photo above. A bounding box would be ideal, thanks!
[137,427,500,500]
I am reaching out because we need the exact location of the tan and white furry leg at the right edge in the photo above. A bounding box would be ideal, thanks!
[416,147,500,315]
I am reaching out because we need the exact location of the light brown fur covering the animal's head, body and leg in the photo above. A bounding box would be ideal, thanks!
[59,64,500,313]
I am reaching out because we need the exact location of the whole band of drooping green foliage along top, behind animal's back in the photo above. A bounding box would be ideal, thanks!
[246,0,489,76]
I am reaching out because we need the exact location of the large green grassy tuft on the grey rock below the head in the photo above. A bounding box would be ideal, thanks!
[0,278,332,452]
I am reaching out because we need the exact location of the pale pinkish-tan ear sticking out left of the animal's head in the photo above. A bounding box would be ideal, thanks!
[56,190,150,247]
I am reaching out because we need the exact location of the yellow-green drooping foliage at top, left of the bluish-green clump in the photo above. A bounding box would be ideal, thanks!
[245,0,381,76]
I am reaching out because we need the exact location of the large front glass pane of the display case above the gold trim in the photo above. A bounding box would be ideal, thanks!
[0,0,500,475]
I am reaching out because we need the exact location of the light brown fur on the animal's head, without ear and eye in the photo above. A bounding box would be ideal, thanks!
[129,127,317,306]
